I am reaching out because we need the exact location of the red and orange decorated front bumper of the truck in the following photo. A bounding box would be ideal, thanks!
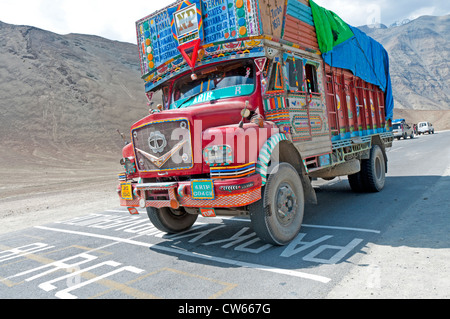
[117,174,262,209]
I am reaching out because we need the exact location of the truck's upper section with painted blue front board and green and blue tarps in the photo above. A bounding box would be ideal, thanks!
[136,0,394,119]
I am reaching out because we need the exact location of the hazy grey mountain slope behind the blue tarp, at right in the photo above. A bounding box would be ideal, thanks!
[360,15,450,110]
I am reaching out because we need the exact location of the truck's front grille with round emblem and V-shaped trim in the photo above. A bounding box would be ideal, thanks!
[131,119,193,172]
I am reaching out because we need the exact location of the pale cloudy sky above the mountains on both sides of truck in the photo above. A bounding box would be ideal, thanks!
[0,0,450,43]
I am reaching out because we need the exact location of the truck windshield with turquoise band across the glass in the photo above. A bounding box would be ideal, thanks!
[170,60,255,109]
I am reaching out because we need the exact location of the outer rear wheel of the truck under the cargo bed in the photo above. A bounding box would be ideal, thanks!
[360,144,386,192]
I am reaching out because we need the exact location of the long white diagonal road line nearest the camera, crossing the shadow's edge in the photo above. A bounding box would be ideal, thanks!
[35,226,331,283]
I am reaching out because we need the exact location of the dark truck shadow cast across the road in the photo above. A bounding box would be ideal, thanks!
[151,176,450,269]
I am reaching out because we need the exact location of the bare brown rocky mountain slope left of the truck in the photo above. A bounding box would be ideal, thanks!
[0,22,148,154]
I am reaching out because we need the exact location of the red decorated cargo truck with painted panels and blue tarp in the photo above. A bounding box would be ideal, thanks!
[118,0,393,245]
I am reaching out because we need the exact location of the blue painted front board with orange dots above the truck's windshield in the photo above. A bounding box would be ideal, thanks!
[136,0,261,76]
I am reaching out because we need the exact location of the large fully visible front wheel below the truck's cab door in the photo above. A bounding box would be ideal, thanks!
[249,163,305,246]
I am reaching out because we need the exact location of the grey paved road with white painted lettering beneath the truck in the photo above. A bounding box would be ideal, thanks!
[0,132,450,302]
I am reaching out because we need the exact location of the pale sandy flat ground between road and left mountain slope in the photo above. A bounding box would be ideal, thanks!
[0,145,122,234]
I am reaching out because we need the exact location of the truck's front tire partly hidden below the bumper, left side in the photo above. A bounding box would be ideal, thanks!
[147,207,198,233]
